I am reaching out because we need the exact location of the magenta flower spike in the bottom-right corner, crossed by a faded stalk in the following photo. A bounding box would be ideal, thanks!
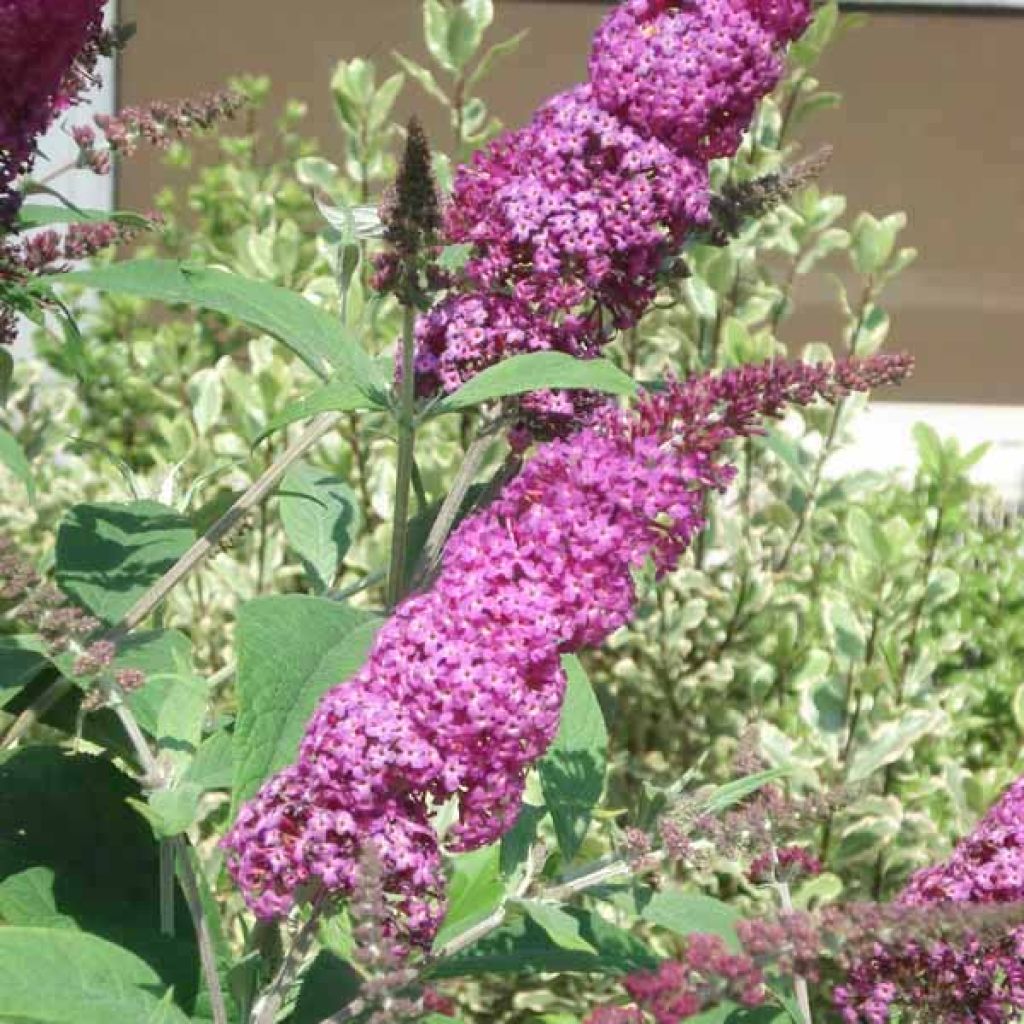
[835,778,1024,1024]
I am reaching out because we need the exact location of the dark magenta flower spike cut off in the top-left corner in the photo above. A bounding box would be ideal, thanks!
[0,0,103,228]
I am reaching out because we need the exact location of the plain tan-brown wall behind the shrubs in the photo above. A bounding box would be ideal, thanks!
[116,0,1024,403]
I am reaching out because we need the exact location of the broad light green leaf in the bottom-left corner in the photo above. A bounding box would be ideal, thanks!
[0,928,187,1024]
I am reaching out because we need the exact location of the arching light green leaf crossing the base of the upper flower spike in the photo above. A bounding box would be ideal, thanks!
[436,352,637,414]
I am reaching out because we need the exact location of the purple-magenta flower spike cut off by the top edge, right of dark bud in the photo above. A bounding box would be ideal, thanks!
[417,0,810,427]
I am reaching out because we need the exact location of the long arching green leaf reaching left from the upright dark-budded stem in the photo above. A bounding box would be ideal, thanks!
[60,259,381,392]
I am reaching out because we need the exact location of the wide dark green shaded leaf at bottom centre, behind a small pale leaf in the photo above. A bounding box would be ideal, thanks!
[430,909,658,978]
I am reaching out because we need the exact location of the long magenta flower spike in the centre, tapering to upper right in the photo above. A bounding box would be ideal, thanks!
[225,356,908,944]
